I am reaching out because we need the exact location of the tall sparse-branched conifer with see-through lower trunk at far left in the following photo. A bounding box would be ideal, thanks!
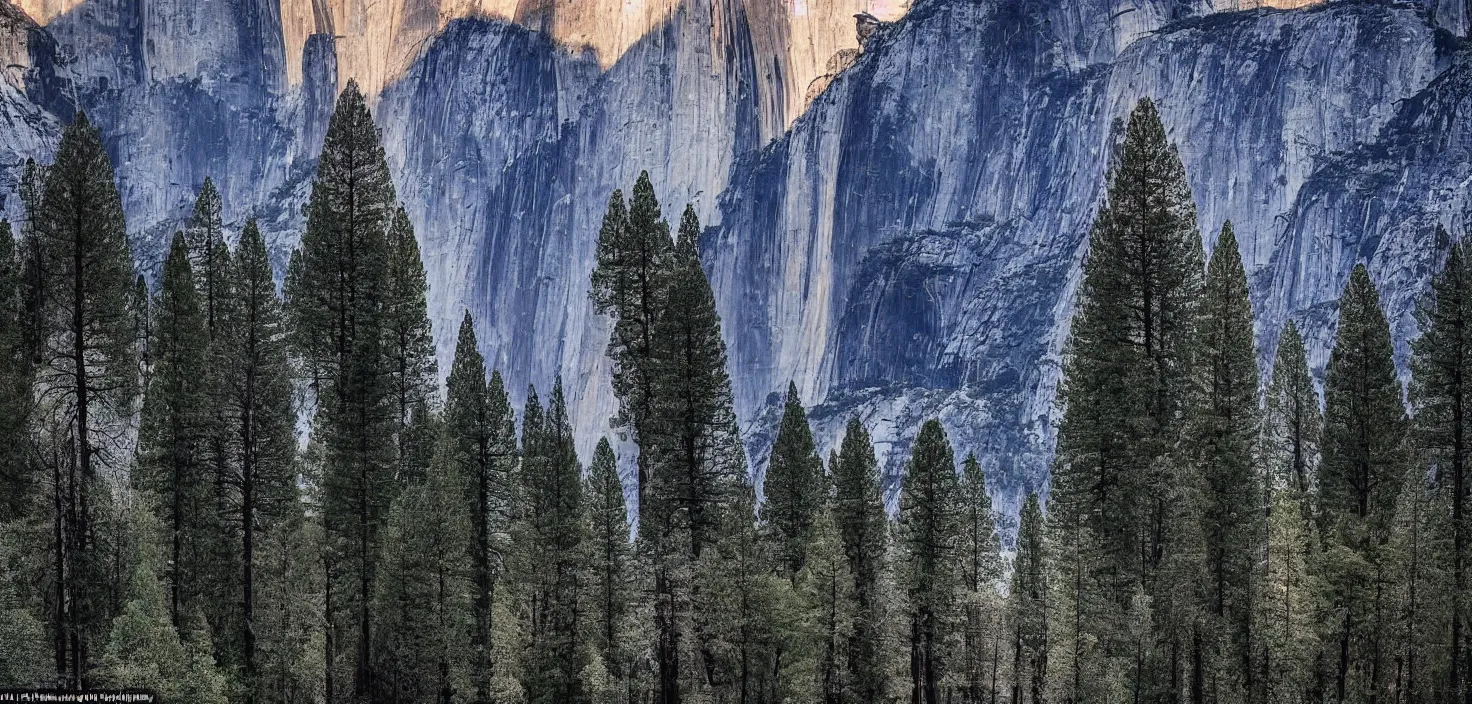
[28,113,137,689]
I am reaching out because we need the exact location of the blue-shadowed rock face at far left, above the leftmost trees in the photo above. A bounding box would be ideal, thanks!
[12,0,297,271]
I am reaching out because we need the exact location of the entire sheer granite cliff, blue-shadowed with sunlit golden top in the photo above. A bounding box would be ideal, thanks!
[0,0,1472,521]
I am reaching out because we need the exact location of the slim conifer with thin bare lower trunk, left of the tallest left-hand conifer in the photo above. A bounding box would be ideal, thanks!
[215,219,299,698]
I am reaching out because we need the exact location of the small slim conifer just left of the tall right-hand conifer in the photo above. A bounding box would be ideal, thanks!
[1007,493,1048,704]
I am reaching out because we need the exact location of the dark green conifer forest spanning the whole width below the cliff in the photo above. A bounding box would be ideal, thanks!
[0,84,1472,704]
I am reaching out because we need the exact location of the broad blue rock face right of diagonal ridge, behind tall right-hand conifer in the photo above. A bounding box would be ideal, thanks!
[704,1,1465,518]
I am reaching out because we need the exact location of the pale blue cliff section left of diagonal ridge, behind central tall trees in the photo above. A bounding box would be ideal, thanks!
[378,0,800,449]
